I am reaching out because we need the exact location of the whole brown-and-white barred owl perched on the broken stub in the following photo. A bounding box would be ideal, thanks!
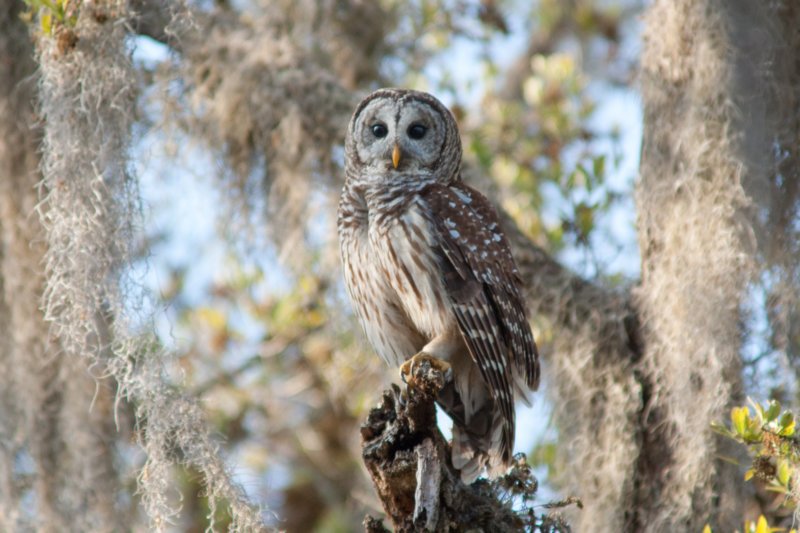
[338,89,539,483]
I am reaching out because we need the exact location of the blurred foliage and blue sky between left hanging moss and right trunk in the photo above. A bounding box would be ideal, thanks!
[133,0,642,531]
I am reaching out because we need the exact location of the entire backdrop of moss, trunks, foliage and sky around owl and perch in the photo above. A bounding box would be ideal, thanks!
[0,0,800,532]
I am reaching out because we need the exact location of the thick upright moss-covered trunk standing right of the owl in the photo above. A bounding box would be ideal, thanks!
[636,0,792,531]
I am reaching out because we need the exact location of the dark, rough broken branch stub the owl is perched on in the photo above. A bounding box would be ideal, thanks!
[361,361,572,533]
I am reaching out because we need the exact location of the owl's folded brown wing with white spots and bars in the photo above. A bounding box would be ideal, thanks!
[424,184,539,460]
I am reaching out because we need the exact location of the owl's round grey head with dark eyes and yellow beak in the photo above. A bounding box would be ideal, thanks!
[345,89,461,186]
